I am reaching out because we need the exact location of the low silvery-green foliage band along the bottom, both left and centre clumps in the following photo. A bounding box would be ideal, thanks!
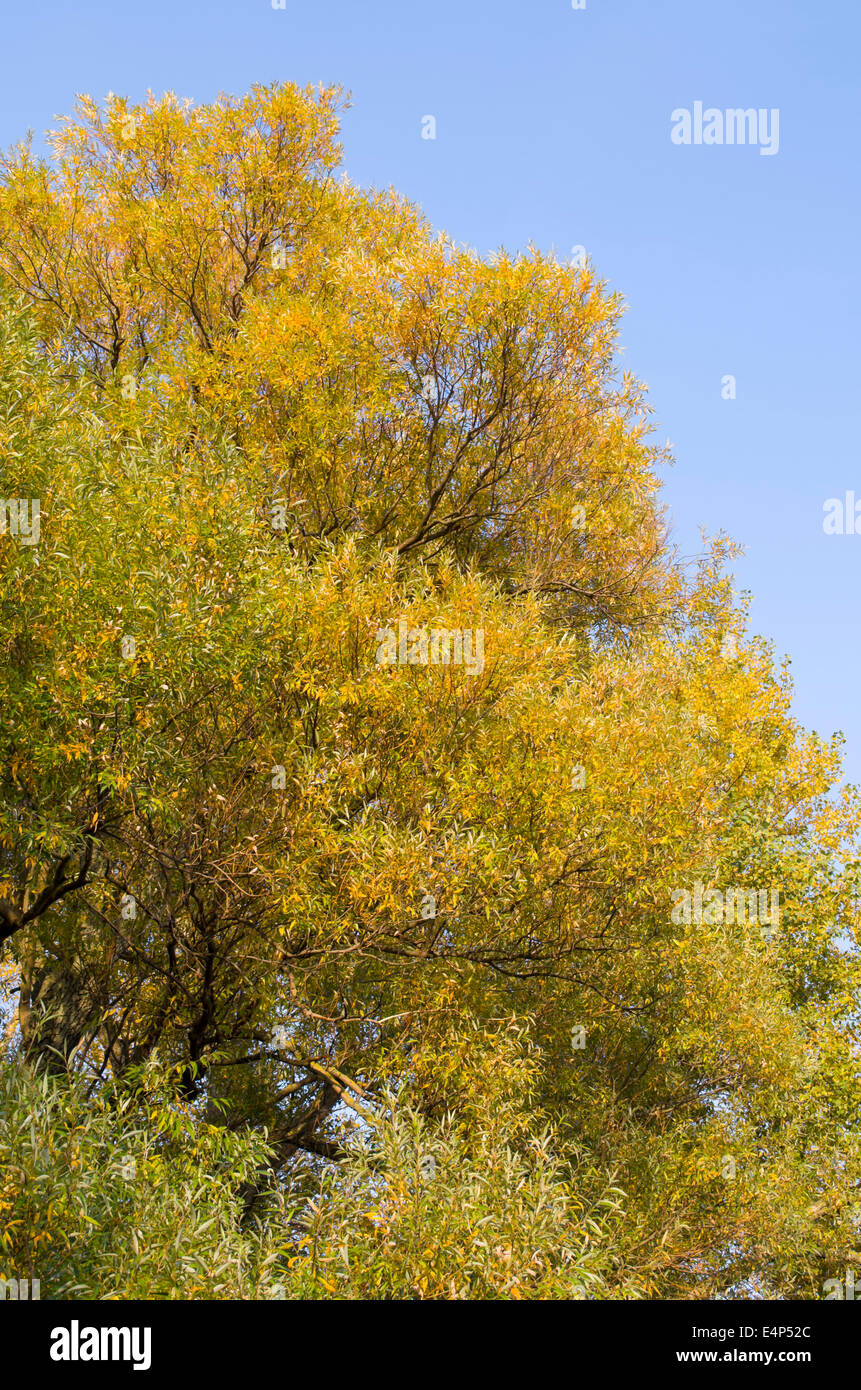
[0,1045,620,1300]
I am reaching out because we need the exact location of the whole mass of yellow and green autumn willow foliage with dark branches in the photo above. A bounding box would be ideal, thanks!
[0,85,861,1298]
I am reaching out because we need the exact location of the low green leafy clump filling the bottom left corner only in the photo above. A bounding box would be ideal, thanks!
[0,1059,278,1300]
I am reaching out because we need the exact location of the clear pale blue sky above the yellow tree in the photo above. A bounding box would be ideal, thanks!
[0,0,861,783]
